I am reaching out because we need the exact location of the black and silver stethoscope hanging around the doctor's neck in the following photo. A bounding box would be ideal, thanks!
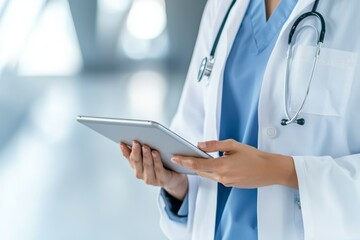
[198,0,326,126]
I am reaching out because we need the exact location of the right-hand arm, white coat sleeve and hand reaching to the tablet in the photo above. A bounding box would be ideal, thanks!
[173,140,360,239]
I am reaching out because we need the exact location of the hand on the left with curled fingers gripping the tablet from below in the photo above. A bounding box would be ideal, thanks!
[120,141,188,200]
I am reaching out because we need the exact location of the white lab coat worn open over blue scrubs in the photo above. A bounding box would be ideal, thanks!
[159,0,360,240]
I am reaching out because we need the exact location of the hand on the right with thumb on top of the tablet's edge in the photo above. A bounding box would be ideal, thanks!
[172,140,298,188]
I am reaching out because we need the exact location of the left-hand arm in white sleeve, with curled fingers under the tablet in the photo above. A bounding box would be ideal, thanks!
[121,0,219,236]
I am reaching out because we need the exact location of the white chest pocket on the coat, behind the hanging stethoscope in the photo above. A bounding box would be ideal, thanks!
[289,45,357,117]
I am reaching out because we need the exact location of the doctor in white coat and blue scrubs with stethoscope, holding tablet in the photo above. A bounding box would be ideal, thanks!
[120,0,360,240]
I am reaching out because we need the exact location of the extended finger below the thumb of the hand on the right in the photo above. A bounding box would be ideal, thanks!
[171,156,219,172]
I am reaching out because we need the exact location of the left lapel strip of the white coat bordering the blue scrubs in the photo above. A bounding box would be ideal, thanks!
[193,0,249,239]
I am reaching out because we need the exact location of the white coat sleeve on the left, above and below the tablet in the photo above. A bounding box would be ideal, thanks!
[159,0,222,239]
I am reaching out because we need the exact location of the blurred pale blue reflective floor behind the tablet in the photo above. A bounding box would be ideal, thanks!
[0,71,183,240]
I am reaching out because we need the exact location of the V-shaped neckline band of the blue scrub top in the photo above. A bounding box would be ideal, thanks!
[248,0,297,52]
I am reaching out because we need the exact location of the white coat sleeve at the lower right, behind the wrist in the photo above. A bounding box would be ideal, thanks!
[294,154,360,239]
